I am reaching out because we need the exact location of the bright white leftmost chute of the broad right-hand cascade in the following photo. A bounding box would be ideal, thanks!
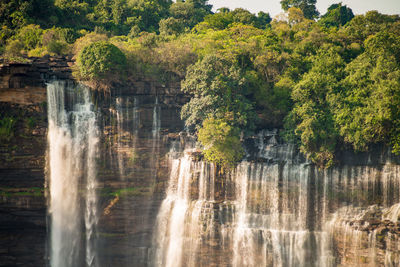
[153,146,215,267]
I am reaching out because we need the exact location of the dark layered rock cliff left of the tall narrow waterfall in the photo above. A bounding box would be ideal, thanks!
[0,59,70,266]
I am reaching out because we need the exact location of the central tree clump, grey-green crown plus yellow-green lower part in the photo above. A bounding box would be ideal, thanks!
[181,55,256,166]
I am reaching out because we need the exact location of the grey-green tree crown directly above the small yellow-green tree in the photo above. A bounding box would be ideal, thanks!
[181,55,256,130]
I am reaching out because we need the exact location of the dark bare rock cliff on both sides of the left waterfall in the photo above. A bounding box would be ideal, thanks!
[0,58,187,266]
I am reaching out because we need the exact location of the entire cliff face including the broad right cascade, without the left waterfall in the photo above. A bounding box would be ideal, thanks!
[0,58,400,266]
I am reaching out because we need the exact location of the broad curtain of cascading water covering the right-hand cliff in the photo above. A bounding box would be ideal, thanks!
[153,132,400,267]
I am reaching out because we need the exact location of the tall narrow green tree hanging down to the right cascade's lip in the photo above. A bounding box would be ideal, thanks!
[291,47,344,166]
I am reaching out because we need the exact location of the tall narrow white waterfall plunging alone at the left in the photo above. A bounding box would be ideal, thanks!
[47,81,98,267]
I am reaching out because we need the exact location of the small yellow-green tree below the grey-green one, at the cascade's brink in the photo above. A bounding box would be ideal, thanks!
[198,118,244,168]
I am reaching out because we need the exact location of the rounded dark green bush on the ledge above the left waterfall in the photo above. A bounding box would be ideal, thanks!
[77,41,126,79]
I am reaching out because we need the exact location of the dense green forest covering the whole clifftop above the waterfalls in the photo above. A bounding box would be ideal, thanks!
[0,0,400,167]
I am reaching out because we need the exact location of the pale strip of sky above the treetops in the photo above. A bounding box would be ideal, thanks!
[208,0,400,17]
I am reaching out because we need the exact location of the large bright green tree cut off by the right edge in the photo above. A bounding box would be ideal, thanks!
[335,31,400,153]
